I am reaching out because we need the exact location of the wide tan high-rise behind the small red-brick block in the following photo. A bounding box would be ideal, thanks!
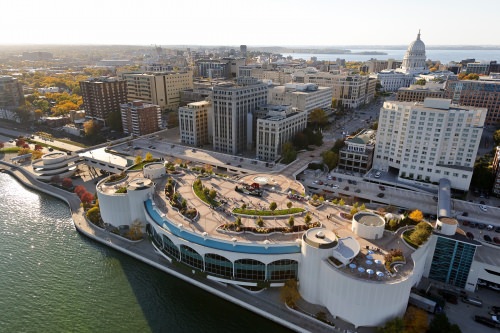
[123,71,193,110]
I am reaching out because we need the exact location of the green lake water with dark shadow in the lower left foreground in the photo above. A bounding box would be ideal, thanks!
[0,173,289,333]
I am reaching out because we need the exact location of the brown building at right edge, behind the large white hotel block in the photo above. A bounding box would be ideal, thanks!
[445,79,500,125]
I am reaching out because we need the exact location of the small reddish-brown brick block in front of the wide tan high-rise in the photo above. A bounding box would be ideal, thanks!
[120,101,161,136]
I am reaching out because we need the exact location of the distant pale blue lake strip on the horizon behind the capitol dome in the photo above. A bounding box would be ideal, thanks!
[283,49,500,64]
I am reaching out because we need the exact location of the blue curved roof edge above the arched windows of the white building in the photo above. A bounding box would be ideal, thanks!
[144,199,300,254]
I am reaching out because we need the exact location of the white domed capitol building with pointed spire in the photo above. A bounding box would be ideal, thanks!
[371,31,428,91]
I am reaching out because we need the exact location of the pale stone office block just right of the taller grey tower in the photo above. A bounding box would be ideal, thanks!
[256,105,307,161]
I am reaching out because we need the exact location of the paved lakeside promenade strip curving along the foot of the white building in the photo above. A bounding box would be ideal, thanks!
[0,160,324,332]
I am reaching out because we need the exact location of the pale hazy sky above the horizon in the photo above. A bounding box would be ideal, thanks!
[0,0,500,46]
